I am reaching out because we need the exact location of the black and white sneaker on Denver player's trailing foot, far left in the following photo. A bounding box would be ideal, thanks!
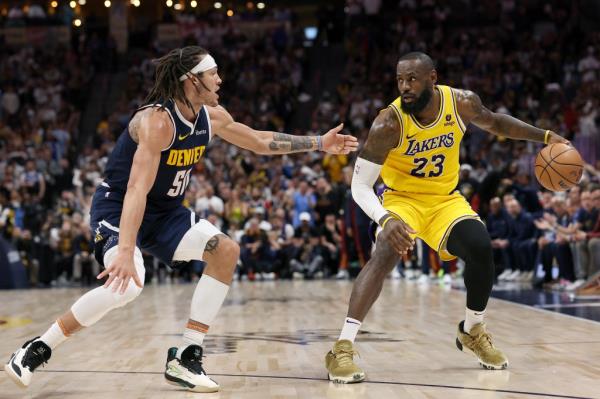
[4,337,52,388]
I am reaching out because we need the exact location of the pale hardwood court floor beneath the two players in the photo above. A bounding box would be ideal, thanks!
[0,281,600,399]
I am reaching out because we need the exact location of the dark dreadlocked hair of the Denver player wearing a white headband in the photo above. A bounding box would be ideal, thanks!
[144,46,208,110]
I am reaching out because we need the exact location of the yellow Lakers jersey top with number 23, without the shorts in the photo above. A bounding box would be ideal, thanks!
[381,85,465,195]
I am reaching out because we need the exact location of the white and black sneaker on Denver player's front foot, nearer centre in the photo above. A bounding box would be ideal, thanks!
[165,345,219,392]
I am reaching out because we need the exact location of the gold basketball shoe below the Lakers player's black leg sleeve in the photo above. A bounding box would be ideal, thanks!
[456,320,508,370]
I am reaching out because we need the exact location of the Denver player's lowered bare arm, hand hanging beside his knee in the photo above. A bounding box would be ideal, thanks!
[98,108,173,294]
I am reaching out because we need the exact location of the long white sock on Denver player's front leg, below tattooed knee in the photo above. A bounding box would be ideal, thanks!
[177,274,229,358]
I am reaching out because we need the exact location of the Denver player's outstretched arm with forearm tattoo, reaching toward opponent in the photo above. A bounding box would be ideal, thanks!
[208,106,358,154]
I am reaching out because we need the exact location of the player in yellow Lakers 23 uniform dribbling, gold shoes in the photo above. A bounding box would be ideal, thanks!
[325,53,569,383]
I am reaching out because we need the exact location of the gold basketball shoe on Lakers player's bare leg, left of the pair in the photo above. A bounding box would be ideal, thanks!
[325,339,365,384]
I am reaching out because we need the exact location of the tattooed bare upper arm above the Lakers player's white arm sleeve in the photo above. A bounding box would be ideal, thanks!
[358,108,400,165]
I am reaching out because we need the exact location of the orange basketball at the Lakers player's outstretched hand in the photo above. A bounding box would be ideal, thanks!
[535,143,583,191]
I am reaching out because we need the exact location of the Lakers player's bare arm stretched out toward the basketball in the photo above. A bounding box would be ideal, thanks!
[455,89,570,145]
